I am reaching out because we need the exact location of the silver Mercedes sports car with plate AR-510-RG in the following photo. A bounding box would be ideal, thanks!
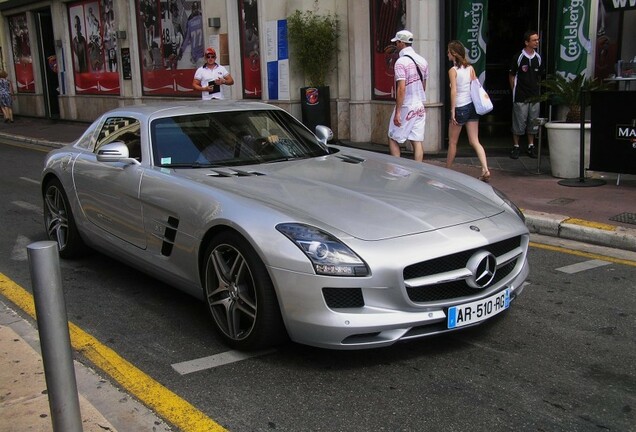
[42,101,529,349]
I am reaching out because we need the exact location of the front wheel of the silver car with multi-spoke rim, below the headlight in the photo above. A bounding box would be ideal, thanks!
[203,232,287,350]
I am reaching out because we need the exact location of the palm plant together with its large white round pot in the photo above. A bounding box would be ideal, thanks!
[534,74,607,178]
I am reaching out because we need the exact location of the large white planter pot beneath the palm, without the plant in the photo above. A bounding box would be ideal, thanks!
[545,122,591,178]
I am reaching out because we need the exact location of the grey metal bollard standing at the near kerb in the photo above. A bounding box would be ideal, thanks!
[27,241,83,432]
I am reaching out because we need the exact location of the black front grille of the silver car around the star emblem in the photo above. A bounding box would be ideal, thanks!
[403,237,522,303]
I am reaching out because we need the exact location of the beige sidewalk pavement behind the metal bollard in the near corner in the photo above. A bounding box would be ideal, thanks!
[0,301,171,432]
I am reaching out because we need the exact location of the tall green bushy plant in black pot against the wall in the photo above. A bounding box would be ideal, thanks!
[287,2,339,131]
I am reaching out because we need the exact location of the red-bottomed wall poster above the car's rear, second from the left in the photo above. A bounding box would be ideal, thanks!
[68,0,120,95]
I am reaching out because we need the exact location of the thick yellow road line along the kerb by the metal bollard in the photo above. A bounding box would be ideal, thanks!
[0,273,226,432]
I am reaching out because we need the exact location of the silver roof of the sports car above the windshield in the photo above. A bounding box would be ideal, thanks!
[104,100,282,120]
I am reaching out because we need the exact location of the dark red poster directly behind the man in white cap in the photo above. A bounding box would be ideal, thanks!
[371,0,406,100]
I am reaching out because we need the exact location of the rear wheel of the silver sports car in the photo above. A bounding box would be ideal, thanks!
[43,179,86,258]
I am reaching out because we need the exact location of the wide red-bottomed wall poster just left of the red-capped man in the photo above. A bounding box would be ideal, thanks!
[137,0,206,96]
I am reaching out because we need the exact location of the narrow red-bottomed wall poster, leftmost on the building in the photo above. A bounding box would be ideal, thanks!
[8,13,35,93]
